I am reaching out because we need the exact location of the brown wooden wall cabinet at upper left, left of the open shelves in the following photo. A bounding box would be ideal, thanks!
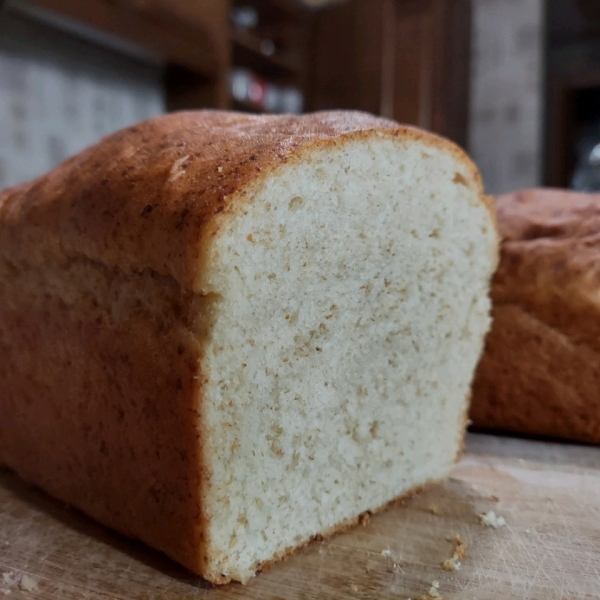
[13,0,231,109]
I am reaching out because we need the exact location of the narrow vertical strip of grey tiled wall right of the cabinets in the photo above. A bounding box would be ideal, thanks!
[469,0,544,194]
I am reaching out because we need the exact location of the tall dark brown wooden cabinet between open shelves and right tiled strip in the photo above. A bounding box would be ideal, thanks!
[311,0,471,145]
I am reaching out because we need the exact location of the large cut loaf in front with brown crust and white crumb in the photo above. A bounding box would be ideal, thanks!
[0,111,497,583]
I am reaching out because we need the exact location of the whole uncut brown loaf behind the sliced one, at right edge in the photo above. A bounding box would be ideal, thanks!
[471,189,600,444]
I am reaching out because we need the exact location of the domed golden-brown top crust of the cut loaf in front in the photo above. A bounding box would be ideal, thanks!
[0,111,488,289]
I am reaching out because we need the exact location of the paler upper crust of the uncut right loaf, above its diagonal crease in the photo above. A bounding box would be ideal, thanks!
[492,190,600,351]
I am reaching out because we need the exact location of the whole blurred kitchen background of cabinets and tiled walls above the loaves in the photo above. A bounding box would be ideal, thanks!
[0,0,600,193]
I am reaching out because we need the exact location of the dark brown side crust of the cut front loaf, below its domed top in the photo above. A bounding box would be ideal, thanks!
[0,258,213,571]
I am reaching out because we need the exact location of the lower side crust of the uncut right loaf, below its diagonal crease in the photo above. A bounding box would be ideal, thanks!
[471,305,600,444]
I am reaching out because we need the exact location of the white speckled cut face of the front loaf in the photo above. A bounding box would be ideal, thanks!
[198,133,496,582]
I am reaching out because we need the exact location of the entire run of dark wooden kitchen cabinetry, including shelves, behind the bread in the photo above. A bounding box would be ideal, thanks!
[9,0,471,127]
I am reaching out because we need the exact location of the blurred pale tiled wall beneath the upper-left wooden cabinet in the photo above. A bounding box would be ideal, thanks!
[0,14,164,189]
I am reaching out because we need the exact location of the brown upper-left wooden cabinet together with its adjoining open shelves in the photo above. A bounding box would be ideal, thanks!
[16,0,311,112]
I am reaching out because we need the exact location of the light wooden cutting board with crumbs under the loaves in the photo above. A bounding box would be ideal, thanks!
[0,434,600,600]
